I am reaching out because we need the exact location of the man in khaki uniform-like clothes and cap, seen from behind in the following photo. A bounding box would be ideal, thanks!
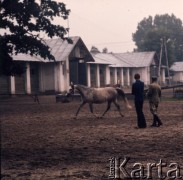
[147,77,162,127]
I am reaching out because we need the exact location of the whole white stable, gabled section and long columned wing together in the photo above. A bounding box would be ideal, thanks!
[0,36,165,94]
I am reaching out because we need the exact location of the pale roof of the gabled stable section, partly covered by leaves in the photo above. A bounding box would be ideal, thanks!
[12,36,80,62]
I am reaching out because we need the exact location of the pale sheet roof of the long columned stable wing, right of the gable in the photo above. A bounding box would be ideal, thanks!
[90,52,155,67]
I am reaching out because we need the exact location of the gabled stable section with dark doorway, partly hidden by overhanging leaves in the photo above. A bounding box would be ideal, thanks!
[0,37,94,94]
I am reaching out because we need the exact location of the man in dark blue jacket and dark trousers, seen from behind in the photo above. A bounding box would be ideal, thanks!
[132,74,146,128]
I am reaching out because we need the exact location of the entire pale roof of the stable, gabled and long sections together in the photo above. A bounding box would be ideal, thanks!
[12,36,155,67]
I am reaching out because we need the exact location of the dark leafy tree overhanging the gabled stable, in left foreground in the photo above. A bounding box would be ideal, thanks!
[0,0,71,75]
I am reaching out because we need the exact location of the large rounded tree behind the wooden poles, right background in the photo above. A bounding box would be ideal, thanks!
[132,14,183,65]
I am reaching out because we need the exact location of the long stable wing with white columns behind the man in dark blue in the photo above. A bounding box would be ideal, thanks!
[87,50,165,87]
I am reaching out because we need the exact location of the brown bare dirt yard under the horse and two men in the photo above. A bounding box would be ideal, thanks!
[0,96,183,180]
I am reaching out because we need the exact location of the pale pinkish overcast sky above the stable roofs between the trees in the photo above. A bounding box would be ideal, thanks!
[56,0,183,53]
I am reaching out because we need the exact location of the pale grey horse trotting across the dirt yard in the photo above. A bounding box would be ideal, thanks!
[71,84,131,118]
